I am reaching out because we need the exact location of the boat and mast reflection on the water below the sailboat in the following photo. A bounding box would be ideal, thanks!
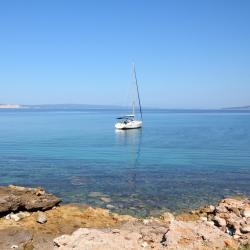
[115,129,142,195]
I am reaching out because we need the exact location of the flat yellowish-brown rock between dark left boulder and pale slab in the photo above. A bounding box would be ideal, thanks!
[0,204,136,250]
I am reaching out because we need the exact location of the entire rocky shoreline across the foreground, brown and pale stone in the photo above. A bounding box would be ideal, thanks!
[0,185,250,250]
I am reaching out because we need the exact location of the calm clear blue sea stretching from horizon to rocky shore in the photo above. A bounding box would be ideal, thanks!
[0,110,250,215]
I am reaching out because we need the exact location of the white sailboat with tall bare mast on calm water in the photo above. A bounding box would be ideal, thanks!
[115,64,142,129]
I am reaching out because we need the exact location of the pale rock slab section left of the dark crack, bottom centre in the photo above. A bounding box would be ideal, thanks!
[54,219,168,250]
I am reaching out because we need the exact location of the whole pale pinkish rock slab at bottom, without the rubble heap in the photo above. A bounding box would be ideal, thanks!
[54,218,232,250]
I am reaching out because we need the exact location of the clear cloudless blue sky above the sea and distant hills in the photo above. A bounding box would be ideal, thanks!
[0,0,250,108]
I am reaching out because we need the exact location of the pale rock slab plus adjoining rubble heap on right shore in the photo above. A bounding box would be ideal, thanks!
[54,198,250,250]
